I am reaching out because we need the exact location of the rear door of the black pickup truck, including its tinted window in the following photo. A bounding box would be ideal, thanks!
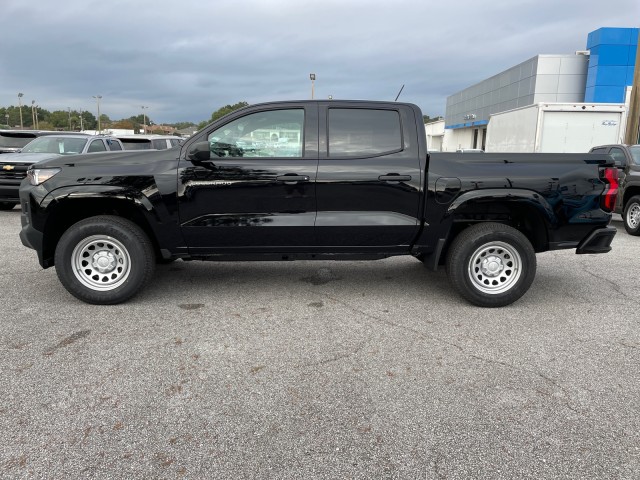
[316,102,421,251]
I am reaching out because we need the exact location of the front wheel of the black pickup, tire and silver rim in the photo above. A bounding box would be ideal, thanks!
[55,215,156,305]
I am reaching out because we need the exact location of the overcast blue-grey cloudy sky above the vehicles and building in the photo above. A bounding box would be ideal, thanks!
[0,0,640,123]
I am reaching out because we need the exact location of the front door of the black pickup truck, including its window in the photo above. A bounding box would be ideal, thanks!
[178,103,318,255]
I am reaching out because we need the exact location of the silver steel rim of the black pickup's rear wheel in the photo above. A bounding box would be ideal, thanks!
[468,242,522,295]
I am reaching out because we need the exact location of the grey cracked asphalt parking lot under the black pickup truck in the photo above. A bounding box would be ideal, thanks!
[0,209,640,479]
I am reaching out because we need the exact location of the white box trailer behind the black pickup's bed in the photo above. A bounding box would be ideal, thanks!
[485,103,626,153]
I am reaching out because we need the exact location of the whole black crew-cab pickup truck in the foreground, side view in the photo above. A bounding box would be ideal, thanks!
[20,100,618,307]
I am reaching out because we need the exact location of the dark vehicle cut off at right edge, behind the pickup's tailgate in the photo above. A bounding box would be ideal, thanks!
[589,143,640,236]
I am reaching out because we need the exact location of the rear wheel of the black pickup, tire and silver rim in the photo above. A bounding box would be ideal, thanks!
[447,223,536,307]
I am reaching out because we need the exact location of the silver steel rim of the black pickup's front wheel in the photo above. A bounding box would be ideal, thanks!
[71,235,131,292]
